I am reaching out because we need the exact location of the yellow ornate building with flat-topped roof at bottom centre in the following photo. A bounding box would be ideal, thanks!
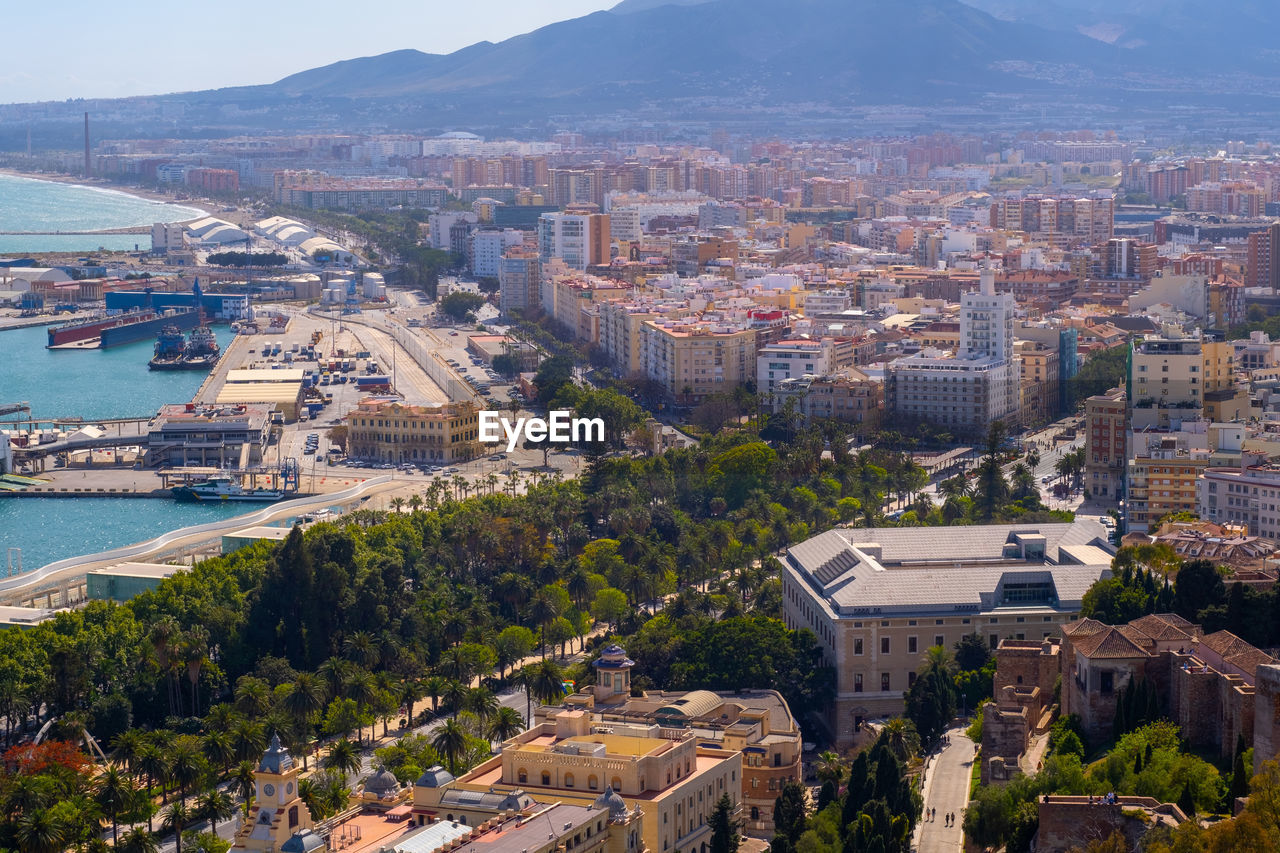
[413,711,742,853]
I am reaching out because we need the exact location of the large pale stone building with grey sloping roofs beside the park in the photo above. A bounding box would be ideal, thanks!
[782,520,1114,747]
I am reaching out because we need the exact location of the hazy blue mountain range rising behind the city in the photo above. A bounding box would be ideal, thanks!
[0,0,1280,147]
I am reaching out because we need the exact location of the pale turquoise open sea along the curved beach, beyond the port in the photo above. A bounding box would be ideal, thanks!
[0,174,205,255]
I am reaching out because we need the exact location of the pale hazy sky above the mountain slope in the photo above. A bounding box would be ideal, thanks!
[0,0,617,104]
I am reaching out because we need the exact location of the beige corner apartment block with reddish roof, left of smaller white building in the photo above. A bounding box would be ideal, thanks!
[640,318,756,405]
